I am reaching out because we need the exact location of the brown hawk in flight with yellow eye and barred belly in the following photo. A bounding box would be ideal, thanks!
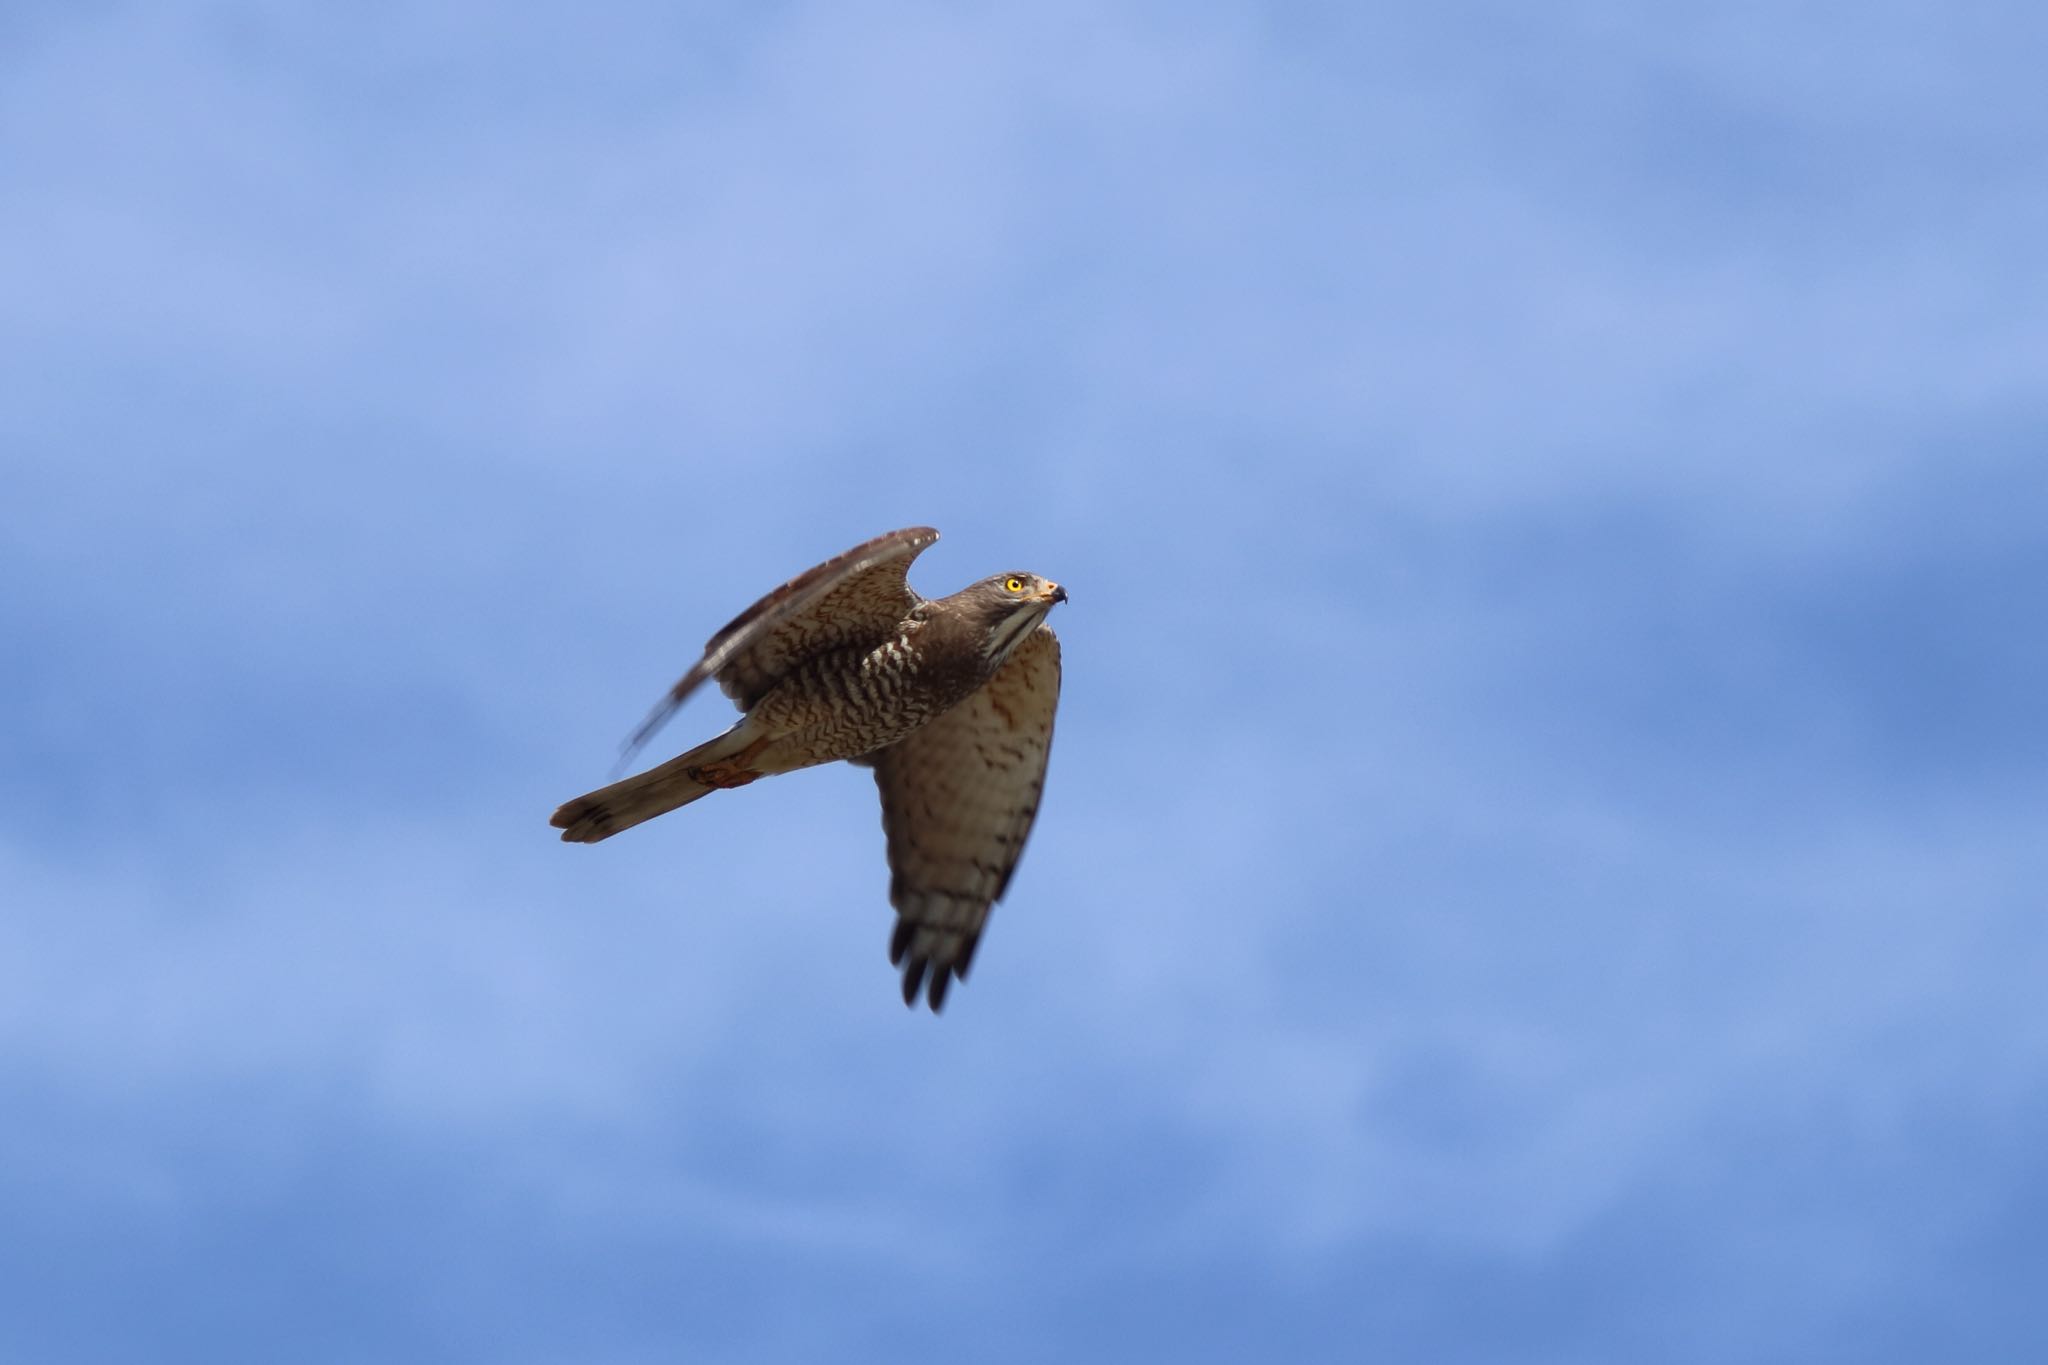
[553,526,1067,1011]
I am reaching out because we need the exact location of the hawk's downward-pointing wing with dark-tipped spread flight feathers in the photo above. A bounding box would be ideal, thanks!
[866,626,1059,1011]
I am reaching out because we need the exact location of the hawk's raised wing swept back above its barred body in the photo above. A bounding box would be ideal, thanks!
[621,526,938,767]
